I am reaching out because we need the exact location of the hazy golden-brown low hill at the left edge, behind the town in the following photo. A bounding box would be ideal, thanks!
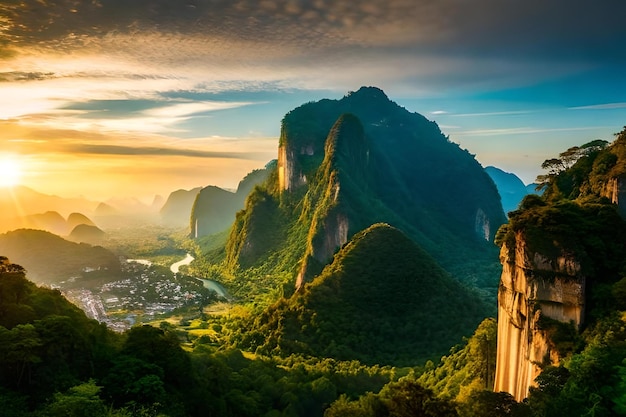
[0,229,120,284]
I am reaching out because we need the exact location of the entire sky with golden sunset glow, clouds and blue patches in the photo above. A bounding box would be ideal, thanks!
[0,0,626,200]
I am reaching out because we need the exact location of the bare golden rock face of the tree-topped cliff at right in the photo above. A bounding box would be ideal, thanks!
[494,232,585,401]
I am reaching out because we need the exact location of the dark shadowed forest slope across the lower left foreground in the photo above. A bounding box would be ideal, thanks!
[0,258,454,417]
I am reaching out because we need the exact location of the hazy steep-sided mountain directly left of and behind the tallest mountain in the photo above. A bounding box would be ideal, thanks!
[190,165,275,238]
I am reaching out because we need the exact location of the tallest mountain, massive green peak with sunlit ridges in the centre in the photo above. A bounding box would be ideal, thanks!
[225,87,505,291]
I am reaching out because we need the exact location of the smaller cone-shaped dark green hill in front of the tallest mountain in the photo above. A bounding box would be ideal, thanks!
[236,224,482,366]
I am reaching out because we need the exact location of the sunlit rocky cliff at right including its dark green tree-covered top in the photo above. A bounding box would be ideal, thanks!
[494,185,626,400]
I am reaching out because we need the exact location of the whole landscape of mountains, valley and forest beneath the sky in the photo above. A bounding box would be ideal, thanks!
[0,87,626,417]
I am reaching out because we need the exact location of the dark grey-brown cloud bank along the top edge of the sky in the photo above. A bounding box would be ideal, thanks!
[0,0,626,57]
